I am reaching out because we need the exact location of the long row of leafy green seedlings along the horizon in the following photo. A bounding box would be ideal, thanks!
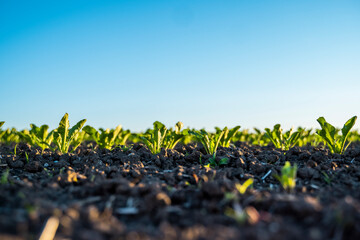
[0,113,360,156]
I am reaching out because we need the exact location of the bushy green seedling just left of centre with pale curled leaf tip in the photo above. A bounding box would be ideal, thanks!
[140,121,187,154]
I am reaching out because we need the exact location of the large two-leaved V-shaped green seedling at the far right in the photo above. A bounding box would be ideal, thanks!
[316,116,357,154]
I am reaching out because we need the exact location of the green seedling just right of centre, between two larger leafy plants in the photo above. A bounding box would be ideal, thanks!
[189,129,224,156]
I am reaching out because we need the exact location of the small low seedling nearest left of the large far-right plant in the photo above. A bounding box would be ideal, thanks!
[265,124,302,150]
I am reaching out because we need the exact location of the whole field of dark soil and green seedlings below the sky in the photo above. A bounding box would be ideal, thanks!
[0,114,360,240]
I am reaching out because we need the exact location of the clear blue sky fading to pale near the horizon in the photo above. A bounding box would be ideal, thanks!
[0,0,360,131]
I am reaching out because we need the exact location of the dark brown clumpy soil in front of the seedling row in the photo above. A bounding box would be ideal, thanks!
[0,142,360,240]
